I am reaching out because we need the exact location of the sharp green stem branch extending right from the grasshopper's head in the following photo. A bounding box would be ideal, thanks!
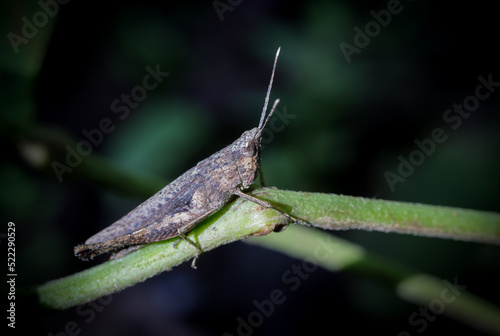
[254,189,500,244]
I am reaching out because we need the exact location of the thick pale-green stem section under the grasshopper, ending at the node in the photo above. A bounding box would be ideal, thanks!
[36,200,287,309]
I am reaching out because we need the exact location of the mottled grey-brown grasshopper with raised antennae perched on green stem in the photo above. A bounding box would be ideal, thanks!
[75,48,286,268]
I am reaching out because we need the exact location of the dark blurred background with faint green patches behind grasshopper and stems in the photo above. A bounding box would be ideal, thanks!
[0,0,500,335]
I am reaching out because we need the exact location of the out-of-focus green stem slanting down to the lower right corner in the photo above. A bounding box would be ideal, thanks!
[246,226,500,334]
